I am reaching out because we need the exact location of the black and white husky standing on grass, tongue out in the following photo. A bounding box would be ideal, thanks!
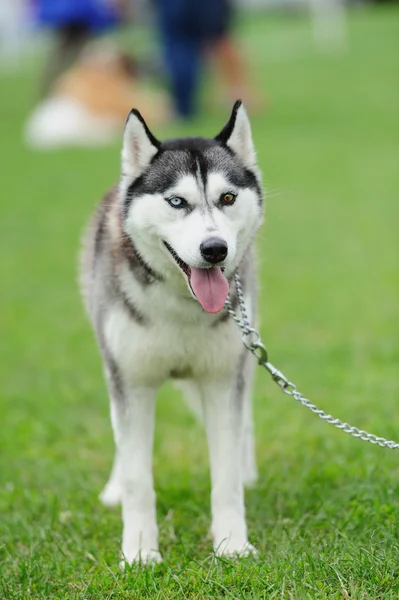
[82,101,263,564]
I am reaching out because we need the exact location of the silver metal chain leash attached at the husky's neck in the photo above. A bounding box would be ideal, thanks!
[225,273,399,450]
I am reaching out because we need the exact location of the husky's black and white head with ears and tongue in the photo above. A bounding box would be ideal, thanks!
[120,101,263,313]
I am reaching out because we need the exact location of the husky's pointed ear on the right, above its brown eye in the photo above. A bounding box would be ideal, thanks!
[215,100,256,169]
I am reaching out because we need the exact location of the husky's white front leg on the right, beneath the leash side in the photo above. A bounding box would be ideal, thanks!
[201,377,256,556]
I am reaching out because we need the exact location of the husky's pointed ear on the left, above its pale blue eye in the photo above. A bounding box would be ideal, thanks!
[122,108,161,179]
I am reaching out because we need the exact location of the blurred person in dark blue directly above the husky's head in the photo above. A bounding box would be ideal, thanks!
[154,0,250,118]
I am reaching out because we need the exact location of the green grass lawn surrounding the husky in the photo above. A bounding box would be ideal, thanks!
[0,9,399,600]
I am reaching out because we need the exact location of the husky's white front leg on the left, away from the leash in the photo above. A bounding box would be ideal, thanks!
[111,386,161,564]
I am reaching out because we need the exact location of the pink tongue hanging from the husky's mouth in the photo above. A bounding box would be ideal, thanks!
[190,267,229,314]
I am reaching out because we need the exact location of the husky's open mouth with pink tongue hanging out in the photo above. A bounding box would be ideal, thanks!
[164,241,229,314]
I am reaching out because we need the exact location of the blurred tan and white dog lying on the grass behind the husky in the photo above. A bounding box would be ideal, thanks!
[26,43,171,148]
